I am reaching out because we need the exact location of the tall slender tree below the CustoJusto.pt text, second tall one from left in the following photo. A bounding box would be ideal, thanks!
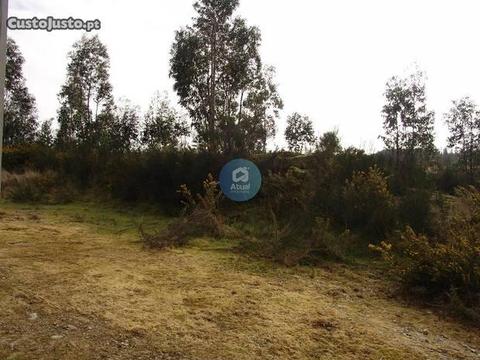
[57,35,114,146]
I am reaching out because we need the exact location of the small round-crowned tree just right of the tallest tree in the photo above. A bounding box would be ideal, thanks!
[285,113,315,152]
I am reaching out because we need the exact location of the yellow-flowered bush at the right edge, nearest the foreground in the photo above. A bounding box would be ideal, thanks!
[371,187,480,317]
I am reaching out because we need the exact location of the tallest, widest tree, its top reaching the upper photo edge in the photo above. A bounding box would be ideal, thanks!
[170,0,282,152]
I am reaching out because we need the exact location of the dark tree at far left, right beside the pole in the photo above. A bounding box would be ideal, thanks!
[3,38,38,145]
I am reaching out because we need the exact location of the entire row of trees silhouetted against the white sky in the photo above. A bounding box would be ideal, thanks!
[4,7,480,188]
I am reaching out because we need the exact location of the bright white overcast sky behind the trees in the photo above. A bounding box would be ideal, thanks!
[9,0,480,151]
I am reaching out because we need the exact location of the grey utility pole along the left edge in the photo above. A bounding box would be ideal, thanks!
[0,0,8,198]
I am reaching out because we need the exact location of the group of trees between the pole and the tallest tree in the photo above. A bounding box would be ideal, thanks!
[4,36,189,153]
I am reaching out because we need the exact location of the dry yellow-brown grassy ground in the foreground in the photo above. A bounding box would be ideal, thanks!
[0,203,480,360]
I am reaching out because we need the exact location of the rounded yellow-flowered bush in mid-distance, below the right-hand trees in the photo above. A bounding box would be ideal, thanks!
[342,167,395,237]
